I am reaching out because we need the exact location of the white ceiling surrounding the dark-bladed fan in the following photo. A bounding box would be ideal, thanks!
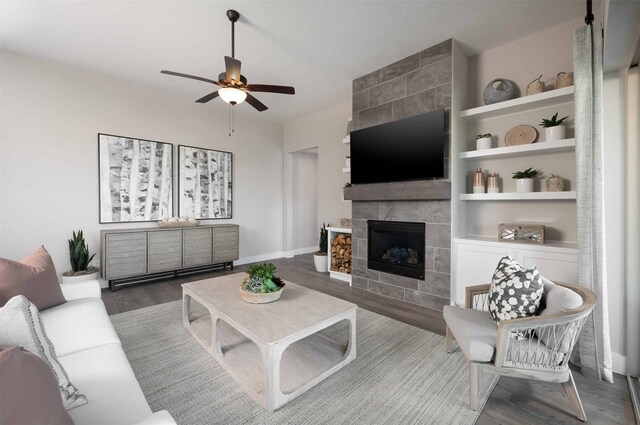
[0,0,585,121]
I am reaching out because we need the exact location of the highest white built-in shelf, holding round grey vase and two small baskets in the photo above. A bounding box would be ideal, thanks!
[460,86,573,120]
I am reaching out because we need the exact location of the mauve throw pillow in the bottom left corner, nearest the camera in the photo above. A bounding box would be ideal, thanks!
[0,347,73,425]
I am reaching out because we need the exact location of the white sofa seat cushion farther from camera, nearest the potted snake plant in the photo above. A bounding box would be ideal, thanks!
[40,298,120,357]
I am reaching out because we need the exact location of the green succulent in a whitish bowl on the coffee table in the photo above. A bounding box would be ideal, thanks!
[240,263,284,304]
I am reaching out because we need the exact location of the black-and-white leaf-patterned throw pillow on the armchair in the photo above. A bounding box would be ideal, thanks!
[489,255,544,328]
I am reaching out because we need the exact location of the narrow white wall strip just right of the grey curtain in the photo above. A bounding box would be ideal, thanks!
[603,70,637,373]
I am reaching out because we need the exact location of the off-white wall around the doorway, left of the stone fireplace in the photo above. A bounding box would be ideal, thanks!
[284,100,351,255]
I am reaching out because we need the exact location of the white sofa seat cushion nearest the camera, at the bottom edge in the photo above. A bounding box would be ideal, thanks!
[60,344,151,425]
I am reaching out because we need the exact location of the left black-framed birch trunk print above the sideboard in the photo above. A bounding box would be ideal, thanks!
[98,133,173,223]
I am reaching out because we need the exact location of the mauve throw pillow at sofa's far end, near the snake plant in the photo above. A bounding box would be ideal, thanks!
[0,246,65,310]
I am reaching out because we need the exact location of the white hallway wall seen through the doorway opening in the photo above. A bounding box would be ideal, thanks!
[292,151,318,253]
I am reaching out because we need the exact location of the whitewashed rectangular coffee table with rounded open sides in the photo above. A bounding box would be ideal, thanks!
[182,273,357,412]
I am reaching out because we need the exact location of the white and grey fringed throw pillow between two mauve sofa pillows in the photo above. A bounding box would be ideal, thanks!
[0,295,87,409]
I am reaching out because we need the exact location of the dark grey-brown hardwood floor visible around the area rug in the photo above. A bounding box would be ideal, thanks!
[103,254,635,425]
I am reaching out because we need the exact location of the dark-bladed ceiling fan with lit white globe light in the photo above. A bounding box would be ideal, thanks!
[160,9,295,126]
